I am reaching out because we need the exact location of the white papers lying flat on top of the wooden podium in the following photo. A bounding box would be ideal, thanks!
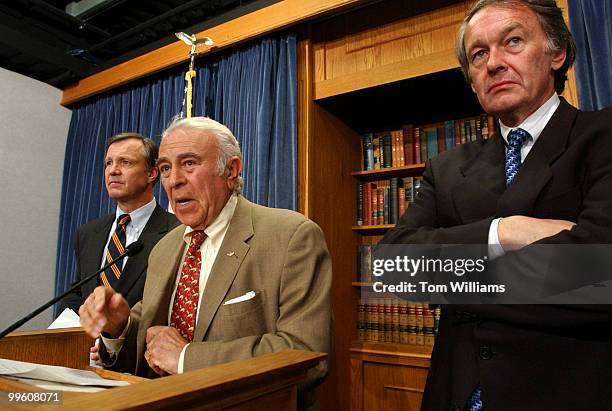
[0,359,129,387]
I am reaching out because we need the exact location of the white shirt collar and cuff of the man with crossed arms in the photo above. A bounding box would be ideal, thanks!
[489,93,561,258]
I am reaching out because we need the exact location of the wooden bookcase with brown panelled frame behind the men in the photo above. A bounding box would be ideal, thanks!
[297,0,577,411]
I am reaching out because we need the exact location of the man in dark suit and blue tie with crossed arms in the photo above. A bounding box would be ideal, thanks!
[382,0,612,411]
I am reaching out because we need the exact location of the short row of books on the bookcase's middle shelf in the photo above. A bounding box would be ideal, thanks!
[356,177,421,226]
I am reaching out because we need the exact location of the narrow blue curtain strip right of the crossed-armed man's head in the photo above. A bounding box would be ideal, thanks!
[568,0,612,110]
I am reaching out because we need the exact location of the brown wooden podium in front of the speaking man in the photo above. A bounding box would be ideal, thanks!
[0,328,327,411]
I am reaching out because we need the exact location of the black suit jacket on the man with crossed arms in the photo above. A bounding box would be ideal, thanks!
[381,99,612,411]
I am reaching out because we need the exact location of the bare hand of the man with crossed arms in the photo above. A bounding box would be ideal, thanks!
[497,215,576,251]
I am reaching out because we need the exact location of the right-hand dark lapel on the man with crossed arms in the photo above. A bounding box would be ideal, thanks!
[496,98,577,216]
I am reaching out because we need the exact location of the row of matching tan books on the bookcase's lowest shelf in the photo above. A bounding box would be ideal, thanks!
[357,296,440,346]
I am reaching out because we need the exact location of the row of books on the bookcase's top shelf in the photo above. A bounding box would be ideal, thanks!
[361,114,495,170]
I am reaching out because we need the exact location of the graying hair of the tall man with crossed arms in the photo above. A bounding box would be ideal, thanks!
[456,0,576,94]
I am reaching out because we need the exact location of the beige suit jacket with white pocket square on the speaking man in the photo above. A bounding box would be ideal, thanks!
[109,197,332,386]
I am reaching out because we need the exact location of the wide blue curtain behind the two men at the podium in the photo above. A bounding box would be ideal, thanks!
[55,35,297,314]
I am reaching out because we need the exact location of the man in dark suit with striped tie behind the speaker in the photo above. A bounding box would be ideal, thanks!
[61,133,178,311]
